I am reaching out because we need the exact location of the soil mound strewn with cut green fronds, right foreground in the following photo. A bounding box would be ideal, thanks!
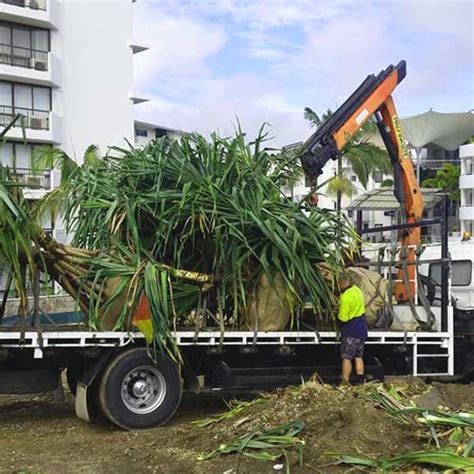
[191,379,474,472]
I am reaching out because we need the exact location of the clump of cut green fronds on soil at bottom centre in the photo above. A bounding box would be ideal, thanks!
[198,420,304,472]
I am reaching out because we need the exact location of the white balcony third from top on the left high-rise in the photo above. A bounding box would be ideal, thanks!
[0,105,62,143]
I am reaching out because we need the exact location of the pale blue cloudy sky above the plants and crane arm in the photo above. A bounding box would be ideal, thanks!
[134,0,474,146]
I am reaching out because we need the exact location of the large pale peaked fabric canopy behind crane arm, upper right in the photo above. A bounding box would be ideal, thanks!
[401,110,474,150]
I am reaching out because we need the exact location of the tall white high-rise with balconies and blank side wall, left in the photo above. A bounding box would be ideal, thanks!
[0,0,147,191]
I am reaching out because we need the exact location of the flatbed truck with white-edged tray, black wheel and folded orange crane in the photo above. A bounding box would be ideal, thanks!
[0,61,474,429]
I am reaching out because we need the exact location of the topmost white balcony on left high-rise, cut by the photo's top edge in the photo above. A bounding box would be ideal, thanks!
[0,0,59,29]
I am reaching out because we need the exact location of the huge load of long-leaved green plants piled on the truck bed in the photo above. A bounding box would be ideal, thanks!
[0,128,355,350]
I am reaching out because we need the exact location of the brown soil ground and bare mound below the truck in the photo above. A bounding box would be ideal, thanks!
[0,378,474,474]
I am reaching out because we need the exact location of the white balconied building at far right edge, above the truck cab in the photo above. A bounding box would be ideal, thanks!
[459,143,474,235]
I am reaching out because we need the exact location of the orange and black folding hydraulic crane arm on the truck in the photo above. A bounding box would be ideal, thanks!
[301,61,423,301]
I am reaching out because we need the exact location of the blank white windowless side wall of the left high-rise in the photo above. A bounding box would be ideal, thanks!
[58,0,134,162]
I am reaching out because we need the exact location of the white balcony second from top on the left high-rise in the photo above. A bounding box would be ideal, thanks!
[0,43,61,86]
